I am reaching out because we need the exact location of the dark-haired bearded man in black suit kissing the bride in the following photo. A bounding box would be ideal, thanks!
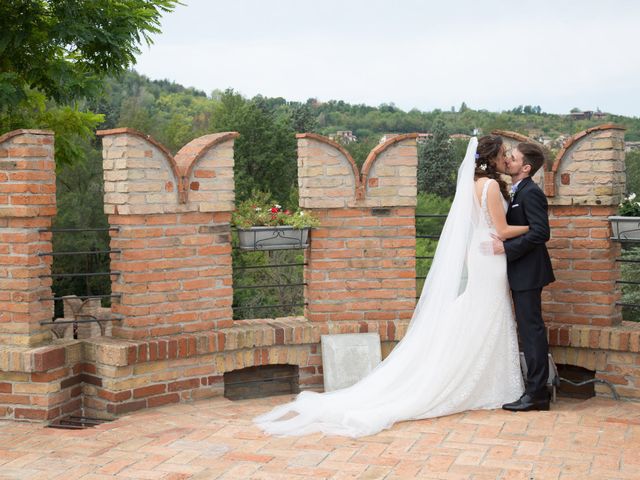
[493,143,555,412]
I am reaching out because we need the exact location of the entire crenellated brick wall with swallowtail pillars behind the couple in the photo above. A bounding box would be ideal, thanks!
[0,126,640,421]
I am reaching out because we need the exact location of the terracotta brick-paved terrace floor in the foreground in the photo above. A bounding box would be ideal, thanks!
[0,396,640,480]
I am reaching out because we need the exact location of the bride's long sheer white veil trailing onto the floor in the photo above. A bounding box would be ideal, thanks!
[254,137,484,437]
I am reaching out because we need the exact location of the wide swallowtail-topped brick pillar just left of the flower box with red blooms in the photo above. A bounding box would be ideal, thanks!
[98,128,237,338]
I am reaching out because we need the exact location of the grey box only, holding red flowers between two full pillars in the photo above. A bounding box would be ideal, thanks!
[238,226,309,250]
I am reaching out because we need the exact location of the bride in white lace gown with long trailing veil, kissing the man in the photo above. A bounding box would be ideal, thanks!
[254,136,529,437]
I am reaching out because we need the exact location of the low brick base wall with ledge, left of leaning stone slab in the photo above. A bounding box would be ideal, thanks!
[84,317,322,418]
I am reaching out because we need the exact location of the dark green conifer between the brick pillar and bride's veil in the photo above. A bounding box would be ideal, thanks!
[418,121,456,197]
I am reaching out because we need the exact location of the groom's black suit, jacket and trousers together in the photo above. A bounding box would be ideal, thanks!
[504,177,555,397]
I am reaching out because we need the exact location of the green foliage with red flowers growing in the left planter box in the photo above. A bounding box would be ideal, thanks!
[231,191,320,228]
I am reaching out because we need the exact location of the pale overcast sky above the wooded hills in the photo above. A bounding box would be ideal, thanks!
[134,0,640,116]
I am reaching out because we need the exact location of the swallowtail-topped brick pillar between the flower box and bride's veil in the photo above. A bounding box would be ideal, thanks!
[298,134,417,340]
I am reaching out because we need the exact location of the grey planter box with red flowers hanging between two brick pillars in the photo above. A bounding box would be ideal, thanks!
[231,192,320,250]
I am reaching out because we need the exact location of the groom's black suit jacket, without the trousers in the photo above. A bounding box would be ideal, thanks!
[504,177,555,291]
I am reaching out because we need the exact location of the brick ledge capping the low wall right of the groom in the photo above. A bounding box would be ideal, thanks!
[547,322,640,353]
